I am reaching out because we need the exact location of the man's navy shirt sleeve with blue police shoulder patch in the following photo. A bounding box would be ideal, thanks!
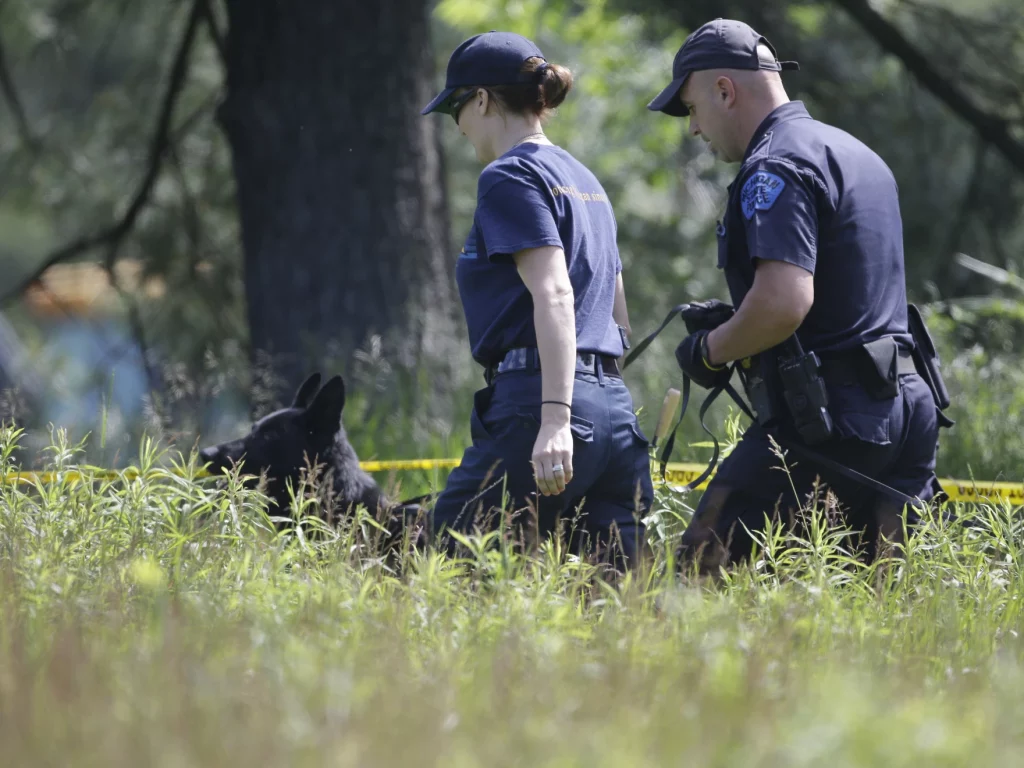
[739,160,818,274]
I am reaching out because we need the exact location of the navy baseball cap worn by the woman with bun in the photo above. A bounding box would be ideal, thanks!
[420,31,547,115]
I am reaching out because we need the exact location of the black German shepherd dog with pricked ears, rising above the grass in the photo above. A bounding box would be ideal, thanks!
[199,373,423,537]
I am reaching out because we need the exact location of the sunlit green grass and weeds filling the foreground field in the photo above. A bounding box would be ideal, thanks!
[0,430,1024,768]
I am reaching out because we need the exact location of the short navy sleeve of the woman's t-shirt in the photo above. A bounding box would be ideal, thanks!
[476,178,562,261]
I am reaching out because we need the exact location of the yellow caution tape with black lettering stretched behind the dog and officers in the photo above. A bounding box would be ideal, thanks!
[2,459,1024,506]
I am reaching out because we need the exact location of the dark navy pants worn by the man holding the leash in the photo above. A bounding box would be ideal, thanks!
[680,374,939,572]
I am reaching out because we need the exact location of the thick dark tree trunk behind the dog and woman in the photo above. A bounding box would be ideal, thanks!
[219,0,457,409]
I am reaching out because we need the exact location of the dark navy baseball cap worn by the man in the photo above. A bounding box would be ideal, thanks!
[647,18,800,118]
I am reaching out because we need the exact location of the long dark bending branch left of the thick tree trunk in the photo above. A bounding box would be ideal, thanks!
[0,0,203,306]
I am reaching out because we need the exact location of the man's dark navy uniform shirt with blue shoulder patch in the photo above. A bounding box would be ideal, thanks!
[718,101,913,352]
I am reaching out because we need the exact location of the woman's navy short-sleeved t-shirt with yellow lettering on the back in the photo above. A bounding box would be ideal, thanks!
[456,143,623,366]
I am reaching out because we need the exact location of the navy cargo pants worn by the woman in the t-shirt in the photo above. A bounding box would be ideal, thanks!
[433,364,653,565]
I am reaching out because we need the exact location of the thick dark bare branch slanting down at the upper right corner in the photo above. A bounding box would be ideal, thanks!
[835,0,1024,174]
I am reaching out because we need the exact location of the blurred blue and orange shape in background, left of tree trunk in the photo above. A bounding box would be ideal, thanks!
[0,260,248,466]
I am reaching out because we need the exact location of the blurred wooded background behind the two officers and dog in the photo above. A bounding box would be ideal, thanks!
[0,0,1024,479]
